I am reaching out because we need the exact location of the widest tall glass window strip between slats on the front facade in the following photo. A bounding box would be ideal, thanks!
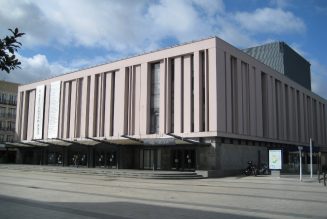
[150,63,160,134]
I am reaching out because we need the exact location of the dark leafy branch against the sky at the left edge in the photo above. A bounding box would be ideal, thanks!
[0,28,25,73]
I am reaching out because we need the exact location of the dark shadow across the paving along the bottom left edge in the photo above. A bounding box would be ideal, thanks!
[0,195,262,219]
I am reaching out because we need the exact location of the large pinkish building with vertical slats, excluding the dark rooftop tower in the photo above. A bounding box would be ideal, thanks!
[7,37,327,176]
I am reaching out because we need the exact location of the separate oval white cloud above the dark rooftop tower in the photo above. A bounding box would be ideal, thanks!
[235,8,306,34]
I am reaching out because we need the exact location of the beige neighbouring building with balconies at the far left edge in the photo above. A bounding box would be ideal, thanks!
[0,81,19,163]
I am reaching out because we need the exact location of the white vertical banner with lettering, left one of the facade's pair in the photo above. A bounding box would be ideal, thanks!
[34,85,45,139]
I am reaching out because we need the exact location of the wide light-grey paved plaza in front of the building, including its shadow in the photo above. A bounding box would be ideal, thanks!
[0,165,327,219]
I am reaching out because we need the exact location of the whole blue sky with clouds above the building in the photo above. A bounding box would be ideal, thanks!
[0,0,327,98]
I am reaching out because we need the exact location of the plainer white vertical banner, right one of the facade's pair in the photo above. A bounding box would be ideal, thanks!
[48,81,61,138]
